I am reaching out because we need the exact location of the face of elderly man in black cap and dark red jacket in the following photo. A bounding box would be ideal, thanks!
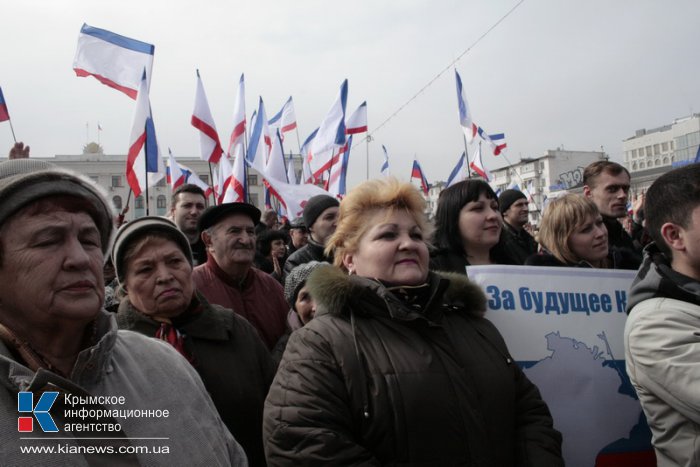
[203,214,255,270]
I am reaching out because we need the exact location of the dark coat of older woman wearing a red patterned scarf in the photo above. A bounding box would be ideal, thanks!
[117,294,275,466]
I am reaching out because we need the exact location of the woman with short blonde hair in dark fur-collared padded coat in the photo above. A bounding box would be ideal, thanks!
[263,179,563,466]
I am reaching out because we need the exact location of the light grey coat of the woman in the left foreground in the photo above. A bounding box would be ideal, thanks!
[0,311,247,467]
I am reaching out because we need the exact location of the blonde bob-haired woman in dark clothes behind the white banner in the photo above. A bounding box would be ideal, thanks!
[525,194,633,269]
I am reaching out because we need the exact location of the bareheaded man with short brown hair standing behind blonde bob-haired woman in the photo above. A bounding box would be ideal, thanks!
[583,160,641,269]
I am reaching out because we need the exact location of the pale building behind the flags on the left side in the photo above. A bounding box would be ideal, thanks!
[3,143,301,220]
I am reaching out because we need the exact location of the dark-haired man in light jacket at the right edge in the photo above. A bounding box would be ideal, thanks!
[625,164,700,467]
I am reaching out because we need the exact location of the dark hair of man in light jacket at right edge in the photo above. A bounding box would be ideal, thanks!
[644,164,700,259]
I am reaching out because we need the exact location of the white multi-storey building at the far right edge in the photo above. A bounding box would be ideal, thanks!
[622,114,700,174]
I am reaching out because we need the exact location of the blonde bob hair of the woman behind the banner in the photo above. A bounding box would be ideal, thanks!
[539,193,599,264]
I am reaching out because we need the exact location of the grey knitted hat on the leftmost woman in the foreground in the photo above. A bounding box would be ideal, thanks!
[0,159,114,256]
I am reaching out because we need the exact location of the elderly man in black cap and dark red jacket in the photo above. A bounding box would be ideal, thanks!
[192,203,288,349]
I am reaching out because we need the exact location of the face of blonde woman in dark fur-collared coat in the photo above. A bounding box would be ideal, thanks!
[343,211,428,285]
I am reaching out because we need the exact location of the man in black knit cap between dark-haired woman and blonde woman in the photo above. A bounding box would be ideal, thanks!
[498,190,537,264]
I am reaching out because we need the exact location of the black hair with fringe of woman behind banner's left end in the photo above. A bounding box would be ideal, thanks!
[435,179,498,254]
